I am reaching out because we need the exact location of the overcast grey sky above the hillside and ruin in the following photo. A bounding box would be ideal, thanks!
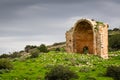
[0,0,120,54]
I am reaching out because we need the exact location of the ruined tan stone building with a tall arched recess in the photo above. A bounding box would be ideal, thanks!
[66,19,108,58]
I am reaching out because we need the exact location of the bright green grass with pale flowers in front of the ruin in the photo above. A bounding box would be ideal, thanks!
[0,51,120,80]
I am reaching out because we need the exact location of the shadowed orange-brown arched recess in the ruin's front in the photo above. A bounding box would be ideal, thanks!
[73,21,94,54]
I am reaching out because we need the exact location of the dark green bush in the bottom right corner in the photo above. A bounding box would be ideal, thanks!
[106,66,120,80]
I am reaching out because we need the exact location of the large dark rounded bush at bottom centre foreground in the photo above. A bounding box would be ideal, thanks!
[45,65,78,80]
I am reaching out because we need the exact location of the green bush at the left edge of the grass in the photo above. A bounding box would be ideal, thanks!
[0,59,13,70]
